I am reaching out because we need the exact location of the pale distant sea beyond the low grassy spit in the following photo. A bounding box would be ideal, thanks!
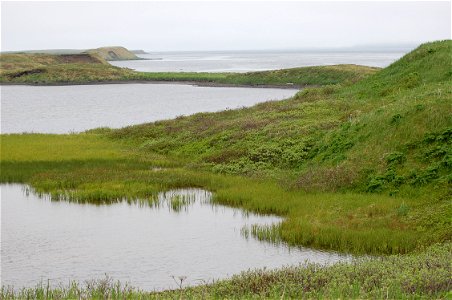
[110,49,411,72]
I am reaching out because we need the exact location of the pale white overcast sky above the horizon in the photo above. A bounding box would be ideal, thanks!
[1,1,451,51]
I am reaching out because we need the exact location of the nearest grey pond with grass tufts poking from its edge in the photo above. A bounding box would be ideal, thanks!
[1,184,350,290]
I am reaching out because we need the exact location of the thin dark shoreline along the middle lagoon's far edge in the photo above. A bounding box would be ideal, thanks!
[0,80,304,90]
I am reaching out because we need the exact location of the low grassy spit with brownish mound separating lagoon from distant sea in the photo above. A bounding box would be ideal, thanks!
[0,48,377,86]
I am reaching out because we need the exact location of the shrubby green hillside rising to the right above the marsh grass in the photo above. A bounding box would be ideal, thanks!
[111,41,452,190]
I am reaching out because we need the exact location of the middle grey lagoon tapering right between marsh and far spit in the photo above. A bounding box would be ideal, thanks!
[1,84,297,133]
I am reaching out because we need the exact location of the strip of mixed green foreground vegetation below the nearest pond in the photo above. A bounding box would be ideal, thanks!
[0,243,452,299]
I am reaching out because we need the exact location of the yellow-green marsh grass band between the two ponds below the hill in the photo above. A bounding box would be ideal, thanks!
[0,133,449,253]
